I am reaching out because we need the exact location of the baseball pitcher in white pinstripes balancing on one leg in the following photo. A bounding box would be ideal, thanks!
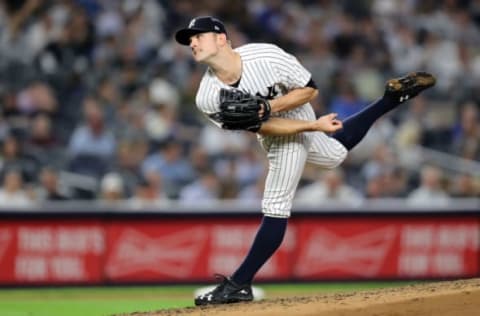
[175,16,435,305]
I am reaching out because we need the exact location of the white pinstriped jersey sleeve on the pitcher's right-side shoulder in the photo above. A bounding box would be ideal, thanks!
[269,46,312,89]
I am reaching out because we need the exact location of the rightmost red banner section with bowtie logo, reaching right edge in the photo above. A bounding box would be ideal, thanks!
[293,217,480,279]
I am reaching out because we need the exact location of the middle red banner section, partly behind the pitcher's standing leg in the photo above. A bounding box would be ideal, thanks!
[105,220,293,282]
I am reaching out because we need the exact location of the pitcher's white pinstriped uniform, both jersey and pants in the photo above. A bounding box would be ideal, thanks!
[196,44,347,217]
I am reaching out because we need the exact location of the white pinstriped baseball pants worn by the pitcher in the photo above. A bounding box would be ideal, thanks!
[261,132,348,218]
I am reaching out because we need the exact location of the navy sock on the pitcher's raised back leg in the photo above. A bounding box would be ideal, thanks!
[332,98,398,150]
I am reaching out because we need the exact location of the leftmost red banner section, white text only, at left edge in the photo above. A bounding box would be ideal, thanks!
[0,220,105,284]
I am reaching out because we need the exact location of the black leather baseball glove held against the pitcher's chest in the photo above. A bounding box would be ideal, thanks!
[218,89,271,132]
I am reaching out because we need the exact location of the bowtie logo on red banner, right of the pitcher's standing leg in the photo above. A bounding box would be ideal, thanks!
[295,227,396,277]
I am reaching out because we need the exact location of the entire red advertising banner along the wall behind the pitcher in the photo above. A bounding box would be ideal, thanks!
[0,214,480,285]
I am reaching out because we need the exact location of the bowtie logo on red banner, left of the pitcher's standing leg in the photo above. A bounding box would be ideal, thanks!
[106,228,207,278]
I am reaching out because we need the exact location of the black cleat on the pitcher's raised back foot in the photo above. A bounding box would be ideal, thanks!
[385,71,436,104]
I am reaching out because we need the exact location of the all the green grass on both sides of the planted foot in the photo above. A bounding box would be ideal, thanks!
[0,282,412,316]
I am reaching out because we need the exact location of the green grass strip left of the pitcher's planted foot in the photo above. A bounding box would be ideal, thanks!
[0,286,194,316]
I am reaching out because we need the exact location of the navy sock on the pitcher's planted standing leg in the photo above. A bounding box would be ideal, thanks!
[231,216,288,285]
